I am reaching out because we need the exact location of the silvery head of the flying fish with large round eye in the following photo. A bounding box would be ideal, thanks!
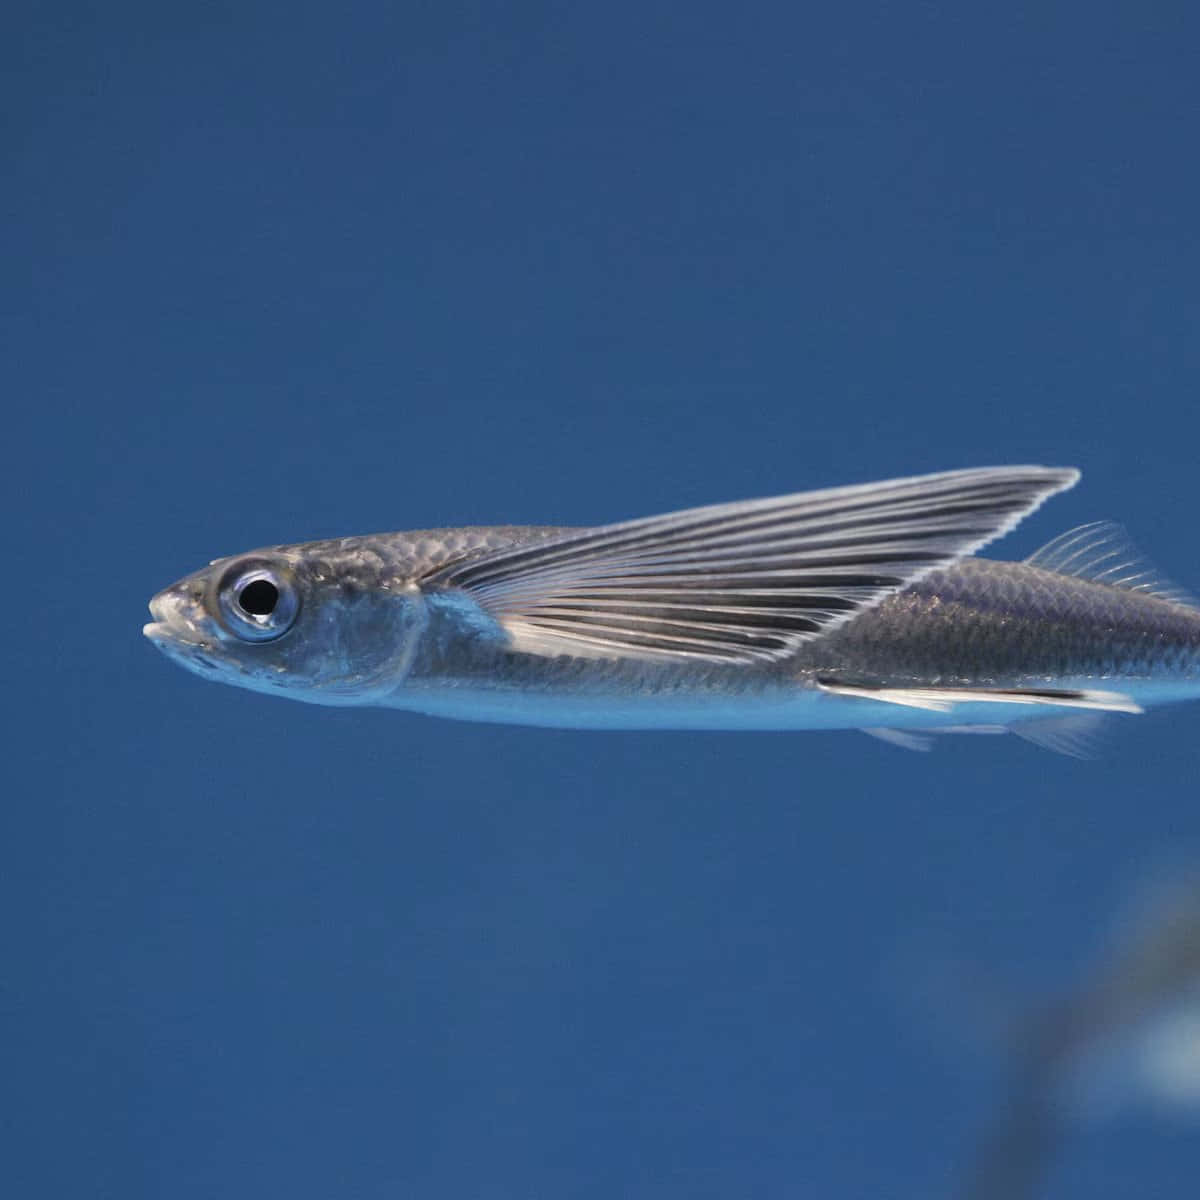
[143,545,426,704]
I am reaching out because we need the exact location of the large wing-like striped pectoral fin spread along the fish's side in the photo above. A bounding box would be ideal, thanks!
[422,467,1079,664]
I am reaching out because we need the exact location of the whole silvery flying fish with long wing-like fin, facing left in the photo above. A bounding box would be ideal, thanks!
[145,468,1200,740]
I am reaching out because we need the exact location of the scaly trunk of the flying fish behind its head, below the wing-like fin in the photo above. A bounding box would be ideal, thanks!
[398,559,1200,730]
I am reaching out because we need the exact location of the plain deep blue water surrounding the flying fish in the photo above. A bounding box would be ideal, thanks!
[9,0,1200,1200]
